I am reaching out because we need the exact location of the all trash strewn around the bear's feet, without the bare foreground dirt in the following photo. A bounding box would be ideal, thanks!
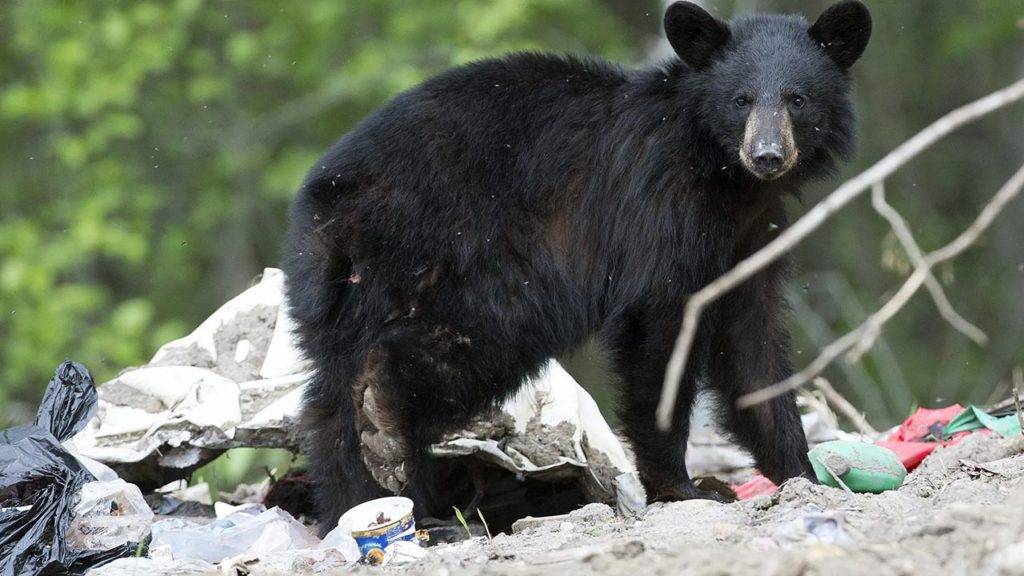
[8,269,1024,576]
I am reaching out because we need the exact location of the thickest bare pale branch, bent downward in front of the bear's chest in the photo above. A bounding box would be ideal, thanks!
[656,79,1024,430]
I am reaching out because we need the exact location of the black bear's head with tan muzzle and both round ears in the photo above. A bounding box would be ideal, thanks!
[665,0,871,180]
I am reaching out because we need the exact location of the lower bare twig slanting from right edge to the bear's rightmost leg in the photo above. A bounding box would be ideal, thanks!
[736,159,1024,408]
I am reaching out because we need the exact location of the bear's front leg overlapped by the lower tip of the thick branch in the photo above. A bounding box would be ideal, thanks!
[605,305,721,502]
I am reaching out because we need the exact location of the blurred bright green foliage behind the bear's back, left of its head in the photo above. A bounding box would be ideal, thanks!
[0,0,654,402]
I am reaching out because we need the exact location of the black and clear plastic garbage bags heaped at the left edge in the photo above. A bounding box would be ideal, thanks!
[0,362,142,576]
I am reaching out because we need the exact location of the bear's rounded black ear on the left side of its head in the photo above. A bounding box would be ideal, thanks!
[665,2,730,70]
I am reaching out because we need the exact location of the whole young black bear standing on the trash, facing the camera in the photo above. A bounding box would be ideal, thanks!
[285,1,871,530]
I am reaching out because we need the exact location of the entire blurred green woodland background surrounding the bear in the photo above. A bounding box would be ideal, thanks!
[0,0,1024,483]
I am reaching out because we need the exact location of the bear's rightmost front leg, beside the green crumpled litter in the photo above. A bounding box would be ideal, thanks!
[708,265,815,484]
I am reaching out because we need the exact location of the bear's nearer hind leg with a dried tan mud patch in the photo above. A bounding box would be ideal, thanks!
[353,320,536,518]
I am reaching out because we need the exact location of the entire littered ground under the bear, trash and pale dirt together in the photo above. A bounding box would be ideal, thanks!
[8,270,1024,576]
